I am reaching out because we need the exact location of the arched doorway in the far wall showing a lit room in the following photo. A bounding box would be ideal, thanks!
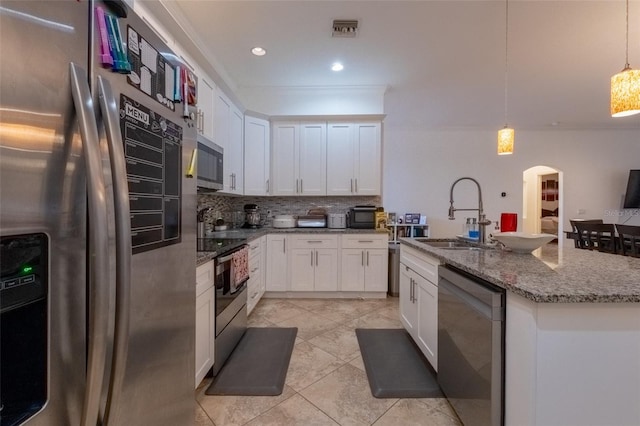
[522,165,564,245]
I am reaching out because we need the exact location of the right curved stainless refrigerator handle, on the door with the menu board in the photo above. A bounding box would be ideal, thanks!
[98,76,132,426]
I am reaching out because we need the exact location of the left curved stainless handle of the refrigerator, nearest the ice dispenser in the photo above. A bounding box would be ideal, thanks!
[69,62,110,426]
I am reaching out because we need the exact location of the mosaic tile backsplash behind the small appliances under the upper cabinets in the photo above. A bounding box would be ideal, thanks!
[198,193,380,228]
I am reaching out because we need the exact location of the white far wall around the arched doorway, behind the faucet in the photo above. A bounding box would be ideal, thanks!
[382,125,640,237]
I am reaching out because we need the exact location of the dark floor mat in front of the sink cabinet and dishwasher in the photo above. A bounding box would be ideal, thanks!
[356,328,444,398]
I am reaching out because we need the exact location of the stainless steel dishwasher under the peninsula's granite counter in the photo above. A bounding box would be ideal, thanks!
[438,265,505,426]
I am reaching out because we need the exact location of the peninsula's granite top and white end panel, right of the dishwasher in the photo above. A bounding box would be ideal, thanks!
[401,239,640,426]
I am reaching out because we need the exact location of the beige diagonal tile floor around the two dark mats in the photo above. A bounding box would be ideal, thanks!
[195,297,461,426]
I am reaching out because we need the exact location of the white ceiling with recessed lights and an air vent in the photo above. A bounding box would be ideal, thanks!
[162,0,640,129]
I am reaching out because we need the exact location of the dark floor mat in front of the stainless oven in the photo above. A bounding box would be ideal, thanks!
[205,327,298,396]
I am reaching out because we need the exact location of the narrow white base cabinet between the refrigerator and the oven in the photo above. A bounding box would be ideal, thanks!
[195,260,216,387]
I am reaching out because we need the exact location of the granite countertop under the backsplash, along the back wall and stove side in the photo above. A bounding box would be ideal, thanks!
[196,227,384,266]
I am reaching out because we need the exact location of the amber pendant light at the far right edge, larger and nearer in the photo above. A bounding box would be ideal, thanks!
[611,0,640,117]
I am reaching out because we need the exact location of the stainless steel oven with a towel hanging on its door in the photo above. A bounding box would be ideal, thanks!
[213,245,248,376]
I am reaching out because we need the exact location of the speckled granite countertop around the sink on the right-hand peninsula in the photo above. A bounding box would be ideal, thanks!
[401,238,640,303]
